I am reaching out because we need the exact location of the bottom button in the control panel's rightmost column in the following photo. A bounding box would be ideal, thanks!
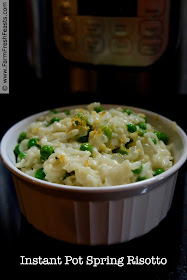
[139,38,162,56]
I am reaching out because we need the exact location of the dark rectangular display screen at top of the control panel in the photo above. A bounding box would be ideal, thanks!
[78,0,137,17]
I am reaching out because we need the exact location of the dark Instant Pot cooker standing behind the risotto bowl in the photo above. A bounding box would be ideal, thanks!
[27,0,181,99]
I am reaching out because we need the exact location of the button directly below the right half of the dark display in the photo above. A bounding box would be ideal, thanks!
[111,21,132,36]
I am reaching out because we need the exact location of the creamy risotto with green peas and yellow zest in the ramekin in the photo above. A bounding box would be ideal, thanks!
[14,102,173,187]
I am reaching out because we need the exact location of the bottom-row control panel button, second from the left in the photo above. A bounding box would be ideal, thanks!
[84,37,104,53]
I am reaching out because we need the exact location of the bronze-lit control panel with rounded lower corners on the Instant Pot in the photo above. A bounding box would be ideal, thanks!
[53,0,170,66]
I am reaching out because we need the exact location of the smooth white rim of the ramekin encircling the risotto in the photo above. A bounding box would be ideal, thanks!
[0,104,187,193]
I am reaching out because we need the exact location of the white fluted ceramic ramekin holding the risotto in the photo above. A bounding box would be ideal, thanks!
[0,105,187,245]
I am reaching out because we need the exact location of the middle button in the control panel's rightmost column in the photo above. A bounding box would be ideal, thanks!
[140,20,163,37]
